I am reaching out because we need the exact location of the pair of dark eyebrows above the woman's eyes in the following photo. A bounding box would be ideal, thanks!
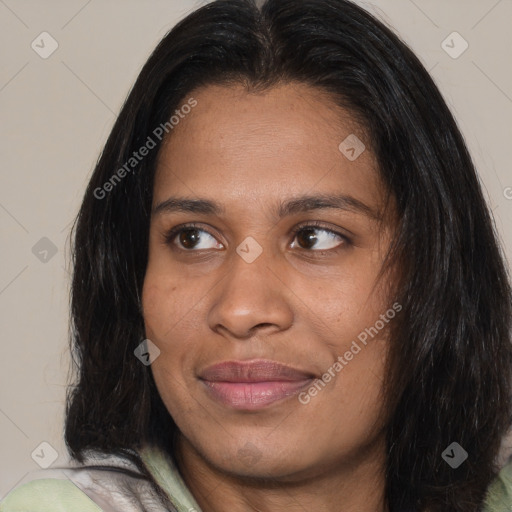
[153,194,380,220]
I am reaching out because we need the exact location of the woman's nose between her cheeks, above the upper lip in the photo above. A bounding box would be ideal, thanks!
[208,251,294,339]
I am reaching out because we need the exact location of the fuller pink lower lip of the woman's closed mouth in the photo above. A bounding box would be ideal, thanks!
[203,379,313,410]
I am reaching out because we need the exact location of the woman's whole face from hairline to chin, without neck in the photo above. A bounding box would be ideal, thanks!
[143,84,396,478]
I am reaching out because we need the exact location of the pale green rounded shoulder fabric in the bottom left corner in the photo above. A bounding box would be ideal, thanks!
[0,478,102,512]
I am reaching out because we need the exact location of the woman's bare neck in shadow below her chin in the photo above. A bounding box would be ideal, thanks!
[176,436,387,512]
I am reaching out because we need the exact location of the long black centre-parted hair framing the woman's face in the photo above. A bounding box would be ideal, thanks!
[65,0,512,512]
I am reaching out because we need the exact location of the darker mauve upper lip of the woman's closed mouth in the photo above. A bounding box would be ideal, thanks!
[199,359,314,382]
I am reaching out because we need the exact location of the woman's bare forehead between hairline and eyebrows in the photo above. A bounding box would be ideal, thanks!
[154,83,382,212]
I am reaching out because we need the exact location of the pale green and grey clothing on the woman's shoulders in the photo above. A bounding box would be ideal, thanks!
[0,447,512,512]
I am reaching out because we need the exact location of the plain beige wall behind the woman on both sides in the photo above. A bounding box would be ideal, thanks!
[0,0,512,498]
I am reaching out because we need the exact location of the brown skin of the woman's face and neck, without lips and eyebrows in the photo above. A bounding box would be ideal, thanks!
[143,83,394,512]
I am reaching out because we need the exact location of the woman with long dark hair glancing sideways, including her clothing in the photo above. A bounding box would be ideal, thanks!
[1,0,512,512]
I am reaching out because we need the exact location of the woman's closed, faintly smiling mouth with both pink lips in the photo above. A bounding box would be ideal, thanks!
[199,359,316,410]
